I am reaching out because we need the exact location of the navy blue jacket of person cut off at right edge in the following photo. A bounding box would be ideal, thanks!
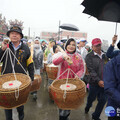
[103,54,120,109]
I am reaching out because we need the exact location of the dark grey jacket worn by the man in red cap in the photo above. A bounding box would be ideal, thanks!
[85,51,108,85]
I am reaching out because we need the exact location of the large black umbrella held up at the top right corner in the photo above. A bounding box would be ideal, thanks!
[82,0,120,34]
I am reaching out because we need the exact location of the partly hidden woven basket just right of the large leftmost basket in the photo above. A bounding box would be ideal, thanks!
[30,75,42,92]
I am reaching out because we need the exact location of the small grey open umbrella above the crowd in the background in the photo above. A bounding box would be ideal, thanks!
[59,24,79,31]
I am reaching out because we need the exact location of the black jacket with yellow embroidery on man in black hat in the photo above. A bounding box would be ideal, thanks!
[0,43,34,80]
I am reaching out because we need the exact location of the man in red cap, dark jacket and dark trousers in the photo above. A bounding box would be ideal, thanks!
[85,38,108,120]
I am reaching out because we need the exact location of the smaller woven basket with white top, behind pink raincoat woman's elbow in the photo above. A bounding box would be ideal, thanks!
[46,64,58,80]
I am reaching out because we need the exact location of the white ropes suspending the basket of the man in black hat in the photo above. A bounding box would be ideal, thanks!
[0,47,28,101]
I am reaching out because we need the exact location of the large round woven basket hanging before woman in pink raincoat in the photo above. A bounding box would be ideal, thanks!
[50,79,86,110]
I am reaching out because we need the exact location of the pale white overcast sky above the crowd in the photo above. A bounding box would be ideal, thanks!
[0,0,120,43]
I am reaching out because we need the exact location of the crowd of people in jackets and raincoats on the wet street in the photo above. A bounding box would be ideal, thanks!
[0,26,120,120]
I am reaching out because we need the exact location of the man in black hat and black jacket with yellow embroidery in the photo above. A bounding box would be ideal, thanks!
[0,26,34,120]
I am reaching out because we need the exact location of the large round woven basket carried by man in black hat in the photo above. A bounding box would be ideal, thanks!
[0,73,31,109]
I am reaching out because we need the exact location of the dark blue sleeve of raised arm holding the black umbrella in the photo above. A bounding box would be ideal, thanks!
[106,45,120,58]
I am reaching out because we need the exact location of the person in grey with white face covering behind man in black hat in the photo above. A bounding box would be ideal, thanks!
[32,39,43,101]
